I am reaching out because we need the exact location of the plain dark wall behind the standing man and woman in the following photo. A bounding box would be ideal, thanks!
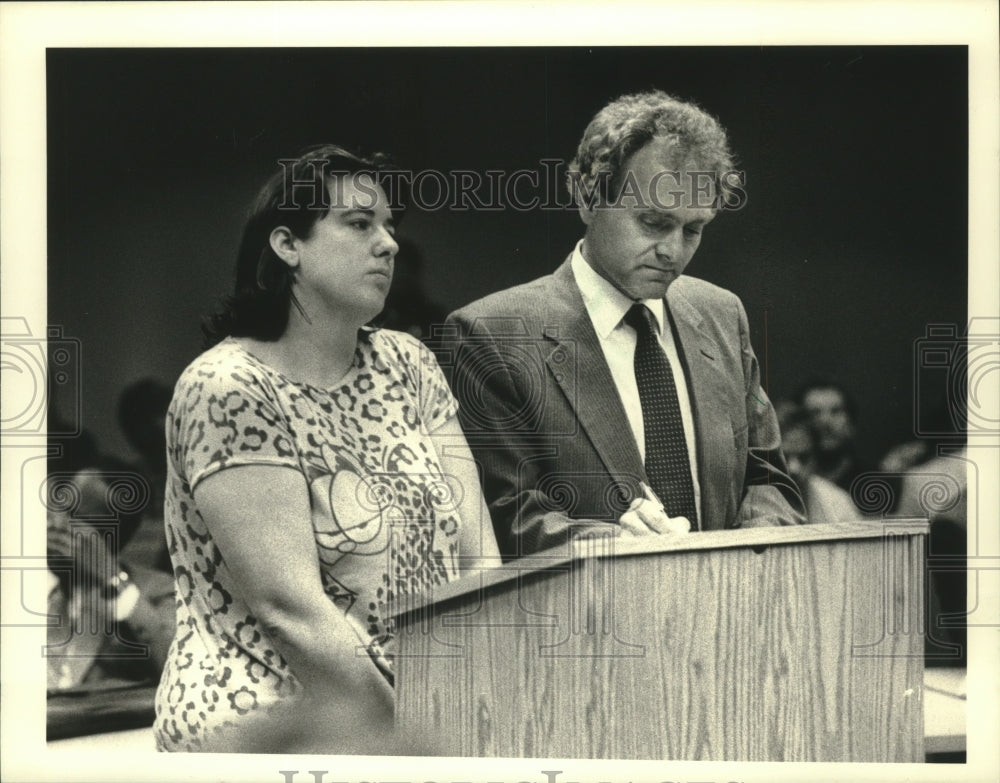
[47,47,968,466]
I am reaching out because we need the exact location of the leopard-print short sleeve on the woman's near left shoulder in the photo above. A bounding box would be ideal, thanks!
[167,352,299,489]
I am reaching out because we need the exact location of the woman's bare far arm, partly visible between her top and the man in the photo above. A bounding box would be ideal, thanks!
[431,416,500,573]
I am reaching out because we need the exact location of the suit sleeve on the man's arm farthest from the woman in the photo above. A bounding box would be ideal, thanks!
[736,298,806,527]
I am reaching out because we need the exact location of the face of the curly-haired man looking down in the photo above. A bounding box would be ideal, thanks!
[580,139,715,300]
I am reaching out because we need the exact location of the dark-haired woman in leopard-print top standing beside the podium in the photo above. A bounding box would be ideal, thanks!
[155,146,497,753]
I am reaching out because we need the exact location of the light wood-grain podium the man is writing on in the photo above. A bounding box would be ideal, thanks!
[395,521,928,762]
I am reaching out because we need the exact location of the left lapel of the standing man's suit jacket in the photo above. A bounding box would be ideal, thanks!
[545,259,645,476]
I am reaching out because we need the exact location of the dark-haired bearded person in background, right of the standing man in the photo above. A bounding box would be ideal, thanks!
[795,378,871,492]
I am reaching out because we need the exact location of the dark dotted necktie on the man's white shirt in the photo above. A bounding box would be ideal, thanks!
[625,304,698,528]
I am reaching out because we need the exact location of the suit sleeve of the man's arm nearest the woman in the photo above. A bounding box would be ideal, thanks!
[437,311,620,560]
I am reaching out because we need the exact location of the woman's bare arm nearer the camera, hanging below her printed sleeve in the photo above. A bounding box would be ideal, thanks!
[194,465,394,753]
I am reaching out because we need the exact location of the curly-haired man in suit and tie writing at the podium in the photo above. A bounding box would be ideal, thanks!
[441,92,803,558]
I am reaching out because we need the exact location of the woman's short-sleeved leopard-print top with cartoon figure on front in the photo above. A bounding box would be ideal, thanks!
[155,329,461,751]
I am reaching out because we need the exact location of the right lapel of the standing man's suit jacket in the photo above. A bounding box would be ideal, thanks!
[666,278,733,529]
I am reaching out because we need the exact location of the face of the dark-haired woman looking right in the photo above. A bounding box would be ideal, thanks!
[295,175,399,325]
